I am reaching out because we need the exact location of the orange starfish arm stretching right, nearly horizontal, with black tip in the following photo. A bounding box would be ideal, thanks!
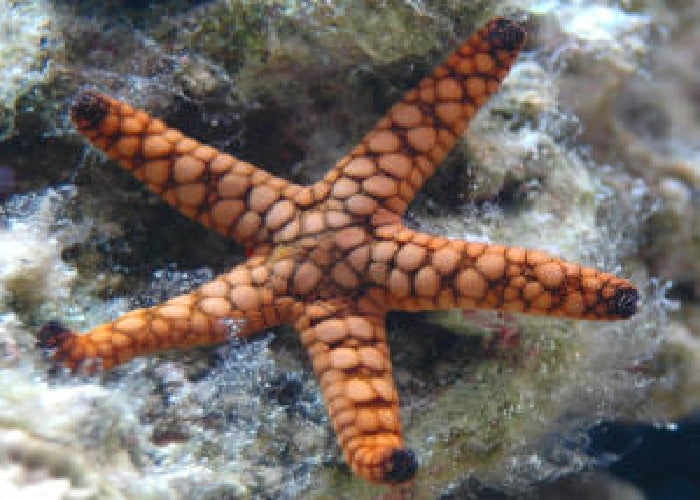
[368,226,638,320]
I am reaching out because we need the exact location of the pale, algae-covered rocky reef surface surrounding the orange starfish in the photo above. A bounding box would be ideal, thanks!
[0,0,700,499]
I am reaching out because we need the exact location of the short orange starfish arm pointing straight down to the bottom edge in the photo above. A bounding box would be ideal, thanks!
[295,303,417,484]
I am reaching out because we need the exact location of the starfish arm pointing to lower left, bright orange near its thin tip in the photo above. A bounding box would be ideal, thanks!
[37,260,303,371]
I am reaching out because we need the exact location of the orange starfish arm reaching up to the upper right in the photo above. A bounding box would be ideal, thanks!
[318,19,525,216]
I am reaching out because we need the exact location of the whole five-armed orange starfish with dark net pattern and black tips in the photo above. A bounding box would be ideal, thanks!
[37,18,638,484]
